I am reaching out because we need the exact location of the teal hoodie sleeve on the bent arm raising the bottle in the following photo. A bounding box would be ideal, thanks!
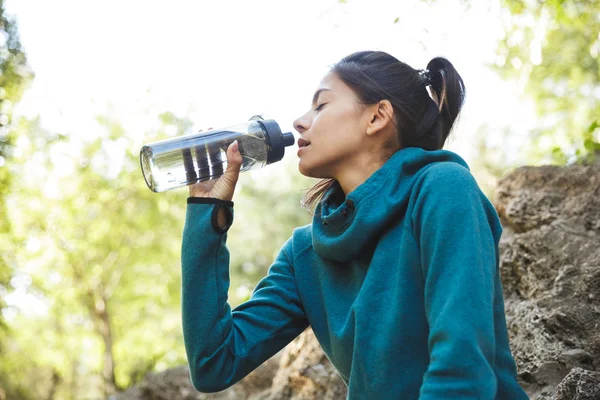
[181,198,308,392]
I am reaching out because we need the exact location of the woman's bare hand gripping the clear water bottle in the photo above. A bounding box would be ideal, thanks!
[189,140,242,201]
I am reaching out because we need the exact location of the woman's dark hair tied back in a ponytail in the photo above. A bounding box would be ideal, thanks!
[303,51,465,210]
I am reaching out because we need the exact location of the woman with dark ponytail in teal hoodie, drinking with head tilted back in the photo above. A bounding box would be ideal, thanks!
[182,51,527,400]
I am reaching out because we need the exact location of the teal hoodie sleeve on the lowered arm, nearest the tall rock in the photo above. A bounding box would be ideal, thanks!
[412,163,501,400]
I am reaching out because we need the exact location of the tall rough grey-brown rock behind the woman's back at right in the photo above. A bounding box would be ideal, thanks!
[494,158,600,400]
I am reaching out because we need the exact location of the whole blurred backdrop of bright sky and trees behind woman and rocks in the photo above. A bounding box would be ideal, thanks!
[0,0,600,399]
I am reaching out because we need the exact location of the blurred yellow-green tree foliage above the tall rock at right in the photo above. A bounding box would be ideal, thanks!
[497,0,600,164]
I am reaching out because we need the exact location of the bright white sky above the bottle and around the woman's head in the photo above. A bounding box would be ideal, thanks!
[5,0,531,166]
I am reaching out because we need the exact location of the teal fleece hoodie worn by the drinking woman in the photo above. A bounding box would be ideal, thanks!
[182,147,527,400]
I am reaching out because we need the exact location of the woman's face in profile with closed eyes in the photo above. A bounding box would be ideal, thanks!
[294,72,369,178]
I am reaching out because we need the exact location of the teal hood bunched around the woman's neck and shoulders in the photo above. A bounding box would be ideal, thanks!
[312,147,469,262]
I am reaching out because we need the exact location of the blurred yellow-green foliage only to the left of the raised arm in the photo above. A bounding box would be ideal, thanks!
[3,114,185,398]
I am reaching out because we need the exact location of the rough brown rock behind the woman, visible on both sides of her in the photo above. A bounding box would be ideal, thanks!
[116,157,600,400]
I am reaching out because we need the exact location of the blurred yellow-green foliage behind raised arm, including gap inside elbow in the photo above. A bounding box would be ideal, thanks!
[2,106,312,399]
